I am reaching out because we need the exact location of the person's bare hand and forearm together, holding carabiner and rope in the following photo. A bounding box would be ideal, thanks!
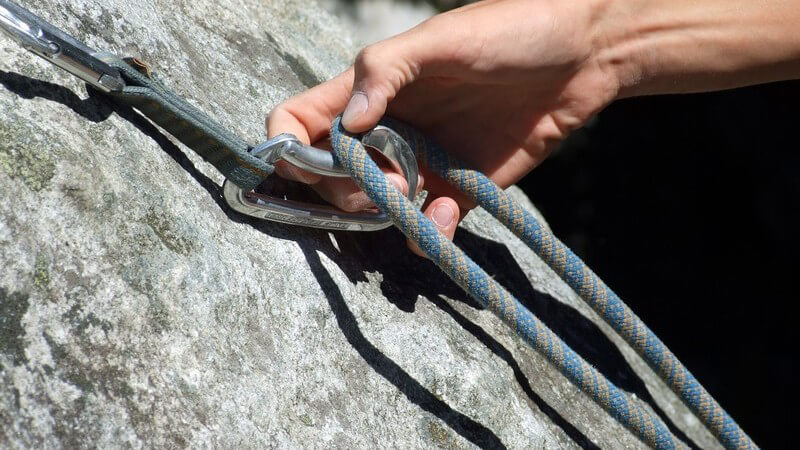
[267,0,800,254]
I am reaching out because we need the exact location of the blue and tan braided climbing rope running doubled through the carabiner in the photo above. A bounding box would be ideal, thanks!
[331,118,757,449]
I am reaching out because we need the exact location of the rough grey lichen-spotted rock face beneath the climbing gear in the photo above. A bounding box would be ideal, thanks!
[0,0,716,448]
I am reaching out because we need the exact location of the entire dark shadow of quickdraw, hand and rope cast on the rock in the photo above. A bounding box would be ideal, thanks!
[0,71,690,448]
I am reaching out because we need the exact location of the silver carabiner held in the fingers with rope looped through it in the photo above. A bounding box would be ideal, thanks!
[223,125,419,231]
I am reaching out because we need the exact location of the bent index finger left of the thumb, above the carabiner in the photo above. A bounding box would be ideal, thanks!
[267,67,353,144]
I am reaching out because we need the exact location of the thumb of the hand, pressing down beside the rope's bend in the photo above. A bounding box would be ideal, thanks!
[342,30,422,133]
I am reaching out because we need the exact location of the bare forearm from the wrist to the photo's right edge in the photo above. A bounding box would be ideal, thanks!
[593,0,800,97]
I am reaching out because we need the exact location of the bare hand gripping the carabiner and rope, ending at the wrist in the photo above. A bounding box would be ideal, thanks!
[267,0,618,253]
